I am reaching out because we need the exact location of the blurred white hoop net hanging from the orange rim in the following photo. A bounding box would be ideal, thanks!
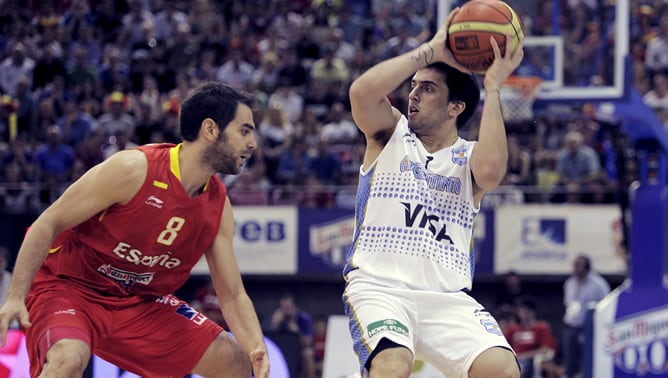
[501,76,543,122]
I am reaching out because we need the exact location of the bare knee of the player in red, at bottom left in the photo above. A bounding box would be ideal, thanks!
[40,340,90,378]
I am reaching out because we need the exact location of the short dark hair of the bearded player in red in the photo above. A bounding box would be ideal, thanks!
[179,81,254,142]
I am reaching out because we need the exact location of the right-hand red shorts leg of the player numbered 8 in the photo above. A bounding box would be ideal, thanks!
[94,295,222,376]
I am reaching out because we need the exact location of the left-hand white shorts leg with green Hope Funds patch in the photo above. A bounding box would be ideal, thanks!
[343,283,416,367]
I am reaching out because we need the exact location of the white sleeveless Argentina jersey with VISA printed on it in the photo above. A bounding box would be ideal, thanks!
[344,116,479,292]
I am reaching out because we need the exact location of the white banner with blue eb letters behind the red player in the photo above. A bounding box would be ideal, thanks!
[192,206,297,274]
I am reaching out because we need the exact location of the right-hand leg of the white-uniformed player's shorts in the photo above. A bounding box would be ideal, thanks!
[416,292,516,377]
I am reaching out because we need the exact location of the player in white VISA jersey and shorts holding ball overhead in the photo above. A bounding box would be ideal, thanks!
[343,10,524,378]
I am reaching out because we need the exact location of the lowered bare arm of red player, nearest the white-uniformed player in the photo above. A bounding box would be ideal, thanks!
[206,198,269,378]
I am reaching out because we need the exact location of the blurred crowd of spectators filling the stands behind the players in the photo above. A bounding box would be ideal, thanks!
[0,0,668,213]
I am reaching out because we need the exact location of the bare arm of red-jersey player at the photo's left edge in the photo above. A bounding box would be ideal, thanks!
[0,151,147,344]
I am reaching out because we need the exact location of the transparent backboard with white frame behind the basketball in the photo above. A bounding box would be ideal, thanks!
[438,0,630,101]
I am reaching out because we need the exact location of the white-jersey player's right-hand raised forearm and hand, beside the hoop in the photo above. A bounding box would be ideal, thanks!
[471,36,524,191]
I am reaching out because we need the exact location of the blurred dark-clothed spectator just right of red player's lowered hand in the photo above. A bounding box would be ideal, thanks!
[268,294,315,378]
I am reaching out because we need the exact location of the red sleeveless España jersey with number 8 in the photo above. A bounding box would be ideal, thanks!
[33,144,227,301]
